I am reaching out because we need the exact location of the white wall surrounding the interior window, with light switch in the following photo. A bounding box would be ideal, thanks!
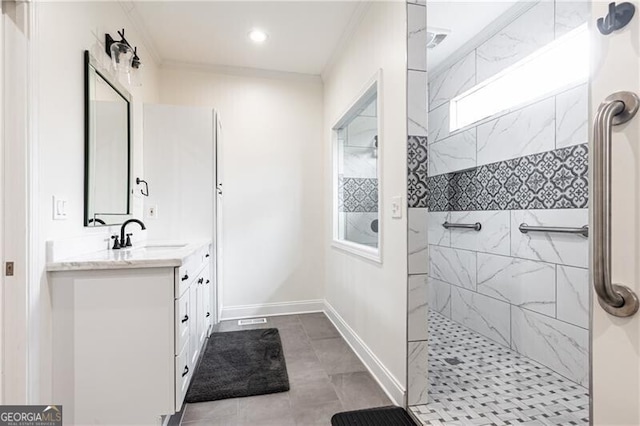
[323,2,407,402]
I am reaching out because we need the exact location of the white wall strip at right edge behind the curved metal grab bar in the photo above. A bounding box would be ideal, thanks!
[589,1,640,425]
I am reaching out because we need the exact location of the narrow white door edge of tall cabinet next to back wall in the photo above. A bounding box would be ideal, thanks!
[213,113,224,322]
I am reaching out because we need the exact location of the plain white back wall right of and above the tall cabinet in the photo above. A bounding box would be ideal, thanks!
[159,68,324,318]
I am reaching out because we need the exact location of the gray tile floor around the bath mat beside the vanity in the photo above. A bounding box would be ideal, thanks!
[181,313,392,426]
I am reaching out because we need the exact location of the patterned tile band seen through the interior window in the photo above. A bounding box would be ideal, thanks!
[338,177,378,213]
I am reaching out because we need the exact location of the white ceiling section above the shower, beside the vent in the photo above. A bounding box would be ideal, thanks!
[427,0,518,70]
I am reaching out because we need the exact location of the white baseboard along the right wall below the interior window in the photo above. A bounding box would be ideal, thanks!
[324,301,406,407]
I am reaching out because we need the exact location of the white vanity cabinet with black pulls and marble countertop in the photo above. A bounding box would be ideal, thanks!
[49,243,214,424]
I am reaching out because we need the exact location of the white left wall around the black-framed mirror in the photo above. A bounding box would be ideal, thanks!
[29,2,158,403]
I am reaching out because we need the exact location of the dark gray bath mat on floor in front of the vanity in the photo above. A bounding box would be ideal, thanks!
[185,328,289,402]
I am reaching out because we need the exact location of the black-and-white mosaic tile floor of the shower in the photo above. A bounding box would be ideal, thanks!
[411,312,589,426]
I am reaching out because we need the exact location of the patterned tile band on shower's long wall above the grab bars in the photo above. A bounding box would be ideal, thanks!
[428,144,589,211]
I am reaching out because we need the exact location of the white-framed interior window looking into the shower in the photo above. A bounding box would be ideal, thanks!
[332,79,381,261]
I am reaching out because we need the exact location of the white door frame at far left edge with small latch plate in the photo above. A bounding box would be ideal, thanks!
[0,2,30,404]
